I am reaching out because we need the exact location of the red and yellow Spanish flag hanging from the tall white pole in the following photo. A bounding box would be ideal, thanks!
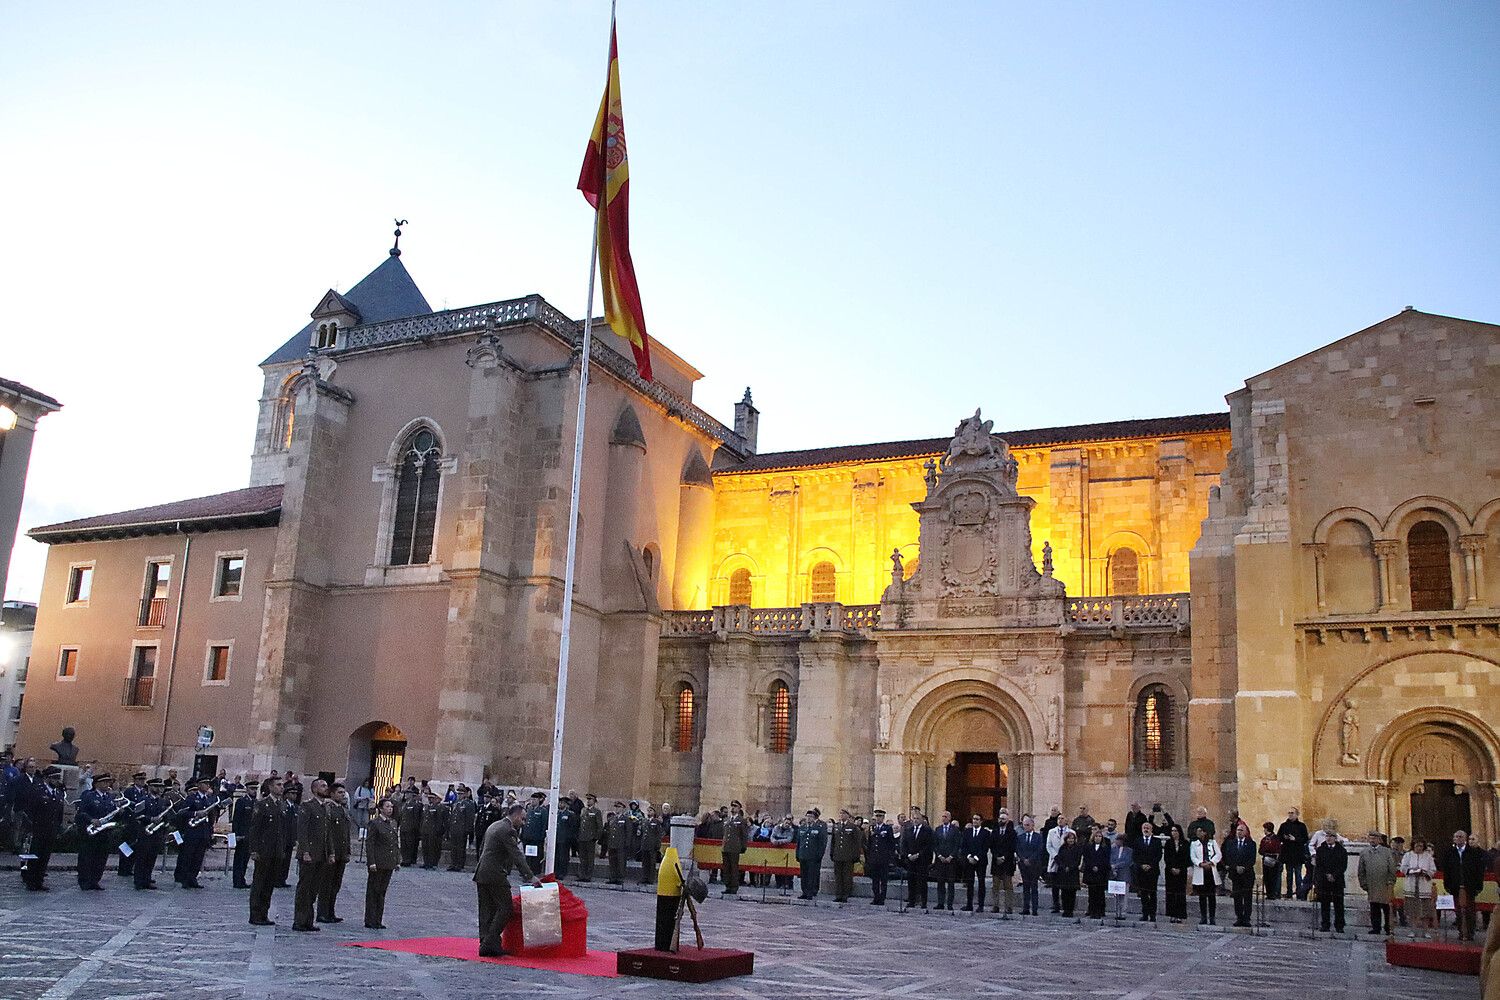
[578,24,651,381]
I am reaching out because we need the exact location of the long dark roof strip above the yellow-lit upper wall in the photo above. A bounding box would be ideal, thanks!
[714,412,1229,475]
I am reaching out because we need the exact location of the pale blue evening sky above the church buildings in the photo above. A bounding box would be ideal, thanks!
[0,0,1500,600]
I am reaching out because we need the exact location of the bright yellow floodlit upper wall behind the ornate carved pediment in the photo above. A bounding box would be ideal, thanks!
[699,417,1229,609]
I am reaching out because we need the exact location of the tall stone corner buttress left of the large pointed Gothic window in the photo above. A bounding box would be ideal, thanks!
[249,370,354,774]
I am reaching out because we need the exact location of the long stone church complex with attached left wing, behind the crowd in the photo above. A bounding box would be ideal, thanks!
[20,253,1500,838]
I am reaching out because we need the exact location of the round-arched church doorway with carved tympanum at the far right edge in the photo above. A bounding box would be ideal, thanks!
[1380,709,1500,844]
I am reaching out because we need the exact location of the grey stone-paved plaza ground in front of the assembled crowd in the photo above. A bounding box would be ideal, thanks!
[0,865,1475,1000]
